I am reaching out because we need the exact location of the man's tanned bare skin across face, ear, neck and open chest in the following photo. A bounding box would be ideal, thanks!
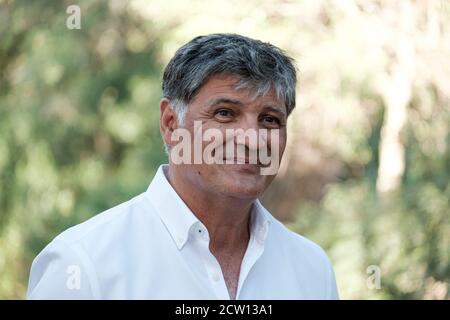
[160,75,287,299]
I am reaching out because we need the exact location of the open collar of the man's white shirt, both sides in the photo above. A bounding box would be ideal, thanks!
[145,164,272,250]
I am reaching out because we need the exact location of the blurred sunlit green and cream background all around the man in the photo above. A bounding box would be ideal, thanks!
[0,0,450,299]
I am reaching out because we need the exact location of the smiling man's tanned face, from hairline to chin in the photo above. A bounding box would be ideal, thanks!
[167,75,287,198]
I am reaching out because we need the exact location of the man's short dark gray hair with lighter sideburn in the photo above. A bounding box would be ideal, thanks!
[162,33,297,153]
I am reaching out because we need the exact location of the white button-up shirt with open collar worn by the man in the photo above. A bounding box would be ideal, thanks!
[27,165,338,299]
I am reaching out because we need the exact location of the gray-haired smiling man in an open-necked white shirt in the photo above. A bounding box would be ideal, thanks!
[28,34,338,299]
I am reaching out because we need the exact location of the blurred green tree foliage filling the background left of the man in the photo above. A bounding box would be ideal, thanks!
[0,1,165,298]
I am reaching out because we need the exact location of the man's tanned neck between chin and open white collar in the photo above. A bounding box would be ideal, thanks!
[167,166,255,253]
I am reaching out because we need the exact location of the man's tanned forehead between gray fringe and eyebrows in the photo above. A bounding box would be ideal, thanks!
[192,75,284,107]
